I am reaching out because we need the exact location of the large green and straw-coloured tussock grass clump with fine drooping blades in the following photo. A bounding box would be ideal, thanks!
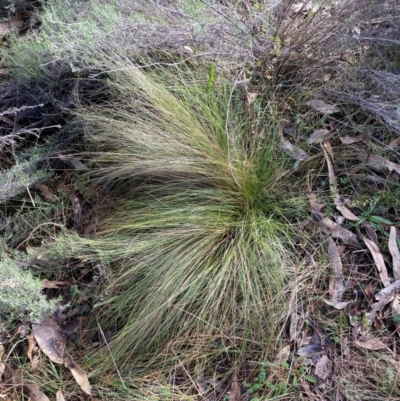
[63,60,299,367]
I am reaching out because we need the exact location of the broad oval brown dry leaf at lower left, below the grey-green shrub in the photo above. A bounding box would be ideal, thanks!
[32,317,66,364]
